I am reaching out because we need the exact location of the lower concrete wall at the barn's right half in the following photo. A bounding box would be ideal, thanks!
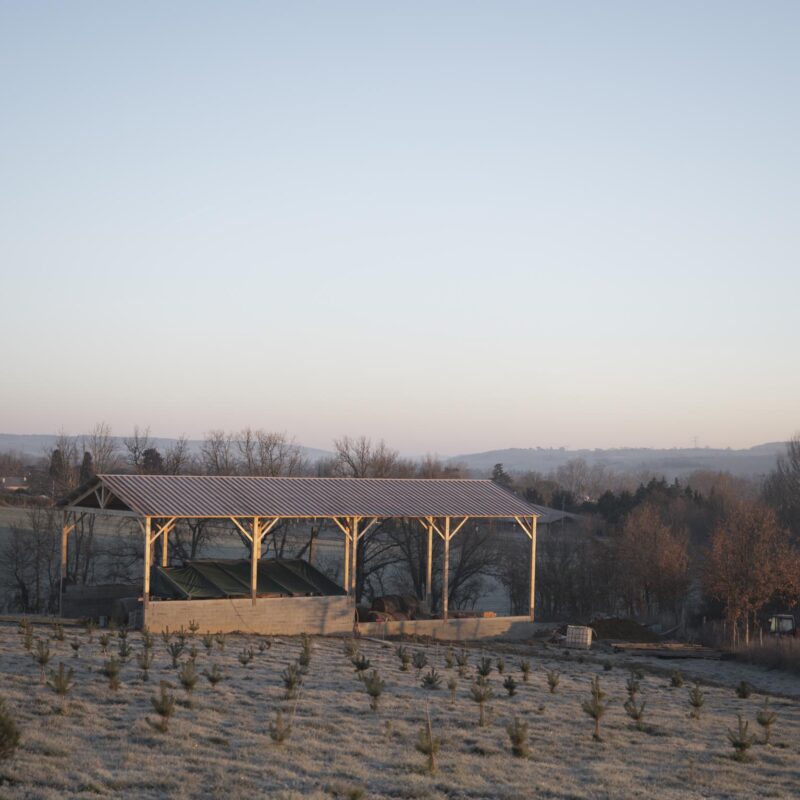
[358,617,548,642]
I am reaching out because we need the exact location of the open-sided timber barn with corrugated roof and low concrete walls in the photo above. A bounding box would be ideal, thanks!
[59,475,539,639]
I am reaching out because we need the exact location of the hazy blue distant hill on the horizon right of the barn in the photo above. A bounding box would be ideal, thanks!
[449,442,786,480]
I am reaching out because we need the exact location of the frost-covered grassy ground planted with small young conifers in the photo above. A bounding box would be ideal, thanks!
[0,625,800,800]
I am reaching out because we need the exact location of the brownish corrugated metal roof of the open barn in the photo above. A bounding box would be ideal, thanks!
[59,475,539,517]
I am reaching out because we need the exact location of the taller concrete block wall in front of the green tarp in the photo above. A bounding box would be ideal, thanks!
[145,596,354,636]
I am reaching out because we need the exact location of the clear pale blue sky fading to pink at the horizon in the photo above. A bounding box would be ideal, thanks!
[0,0,800,455]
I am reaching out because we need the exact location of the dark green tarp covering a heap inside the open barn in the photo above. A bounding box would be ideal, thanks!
[150,558,344,600]
